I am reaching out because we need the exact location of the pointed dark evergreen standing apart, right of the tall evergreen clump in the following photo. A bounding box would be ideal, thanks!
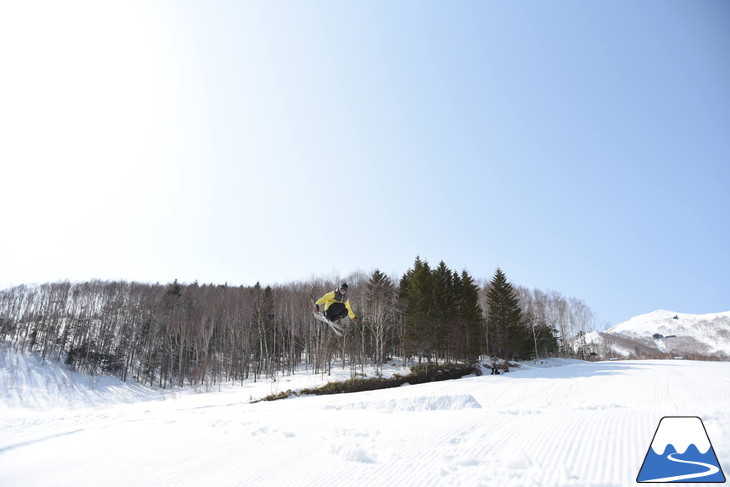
[487,268,532,359]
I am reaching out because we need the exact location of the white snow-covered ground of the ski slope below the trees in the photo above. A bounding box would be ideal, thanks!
[0,349,730,487]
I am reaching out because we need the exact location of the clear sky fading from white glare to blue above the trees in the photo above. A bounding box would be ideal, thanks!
[0,0,730,324]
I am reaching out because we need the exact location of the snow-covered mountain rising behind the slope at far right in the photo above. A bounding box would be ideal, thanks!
[586,310,730,359]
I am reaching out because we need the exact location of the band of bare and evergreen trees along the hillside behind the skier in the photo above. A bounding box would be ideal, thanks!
[0,258,595,387]
